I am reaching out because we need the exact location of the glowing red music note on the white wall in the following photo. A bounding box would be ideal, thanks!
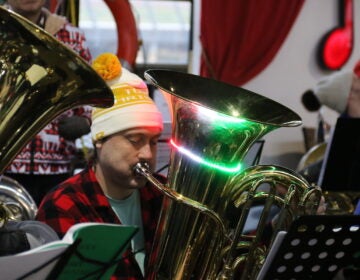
[320,0,354,70]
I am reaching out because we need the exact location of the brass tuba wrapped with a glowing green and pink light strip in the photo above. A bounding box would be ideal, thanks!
[136,70,321,279]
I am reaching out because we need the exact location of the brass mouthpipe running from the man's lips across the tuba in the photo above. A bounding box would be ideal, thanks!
[135,162,227,238]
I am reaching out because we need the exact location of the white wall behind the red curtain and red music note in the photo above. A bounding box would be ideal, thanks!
[190,0,360,167]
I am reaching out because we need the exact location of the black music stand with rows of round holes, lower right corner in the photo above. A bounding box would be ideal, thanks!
[257,215,360,280]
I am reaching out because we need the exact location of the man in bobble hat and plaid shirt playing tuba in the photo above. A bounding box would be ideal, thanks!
[36,53,165,279]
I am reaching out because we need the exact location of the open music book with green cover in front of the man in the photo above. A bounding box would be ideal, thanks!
[0,222,138,280]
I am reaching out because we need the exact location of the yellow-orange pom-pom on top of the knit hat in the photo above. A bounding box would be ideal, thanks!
[92,53,122,81]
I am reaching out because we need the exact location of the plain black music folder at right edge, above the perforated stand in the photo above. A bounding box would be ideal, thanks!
[318,118,360,191]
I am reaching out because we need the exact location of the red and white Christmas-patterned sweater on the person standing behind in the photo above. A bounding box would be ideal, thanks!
[6,23,91,175]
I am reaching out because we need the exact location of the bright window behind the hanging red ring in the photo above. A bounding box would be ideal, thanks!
[79,0,192,66]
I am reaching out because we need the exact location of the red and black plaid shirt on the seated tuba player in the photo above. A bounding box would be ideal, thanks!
[36,168,165,280]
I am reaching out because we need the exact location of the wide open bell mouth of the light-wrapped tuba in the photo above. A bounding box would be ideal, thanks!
[144,69,302,127]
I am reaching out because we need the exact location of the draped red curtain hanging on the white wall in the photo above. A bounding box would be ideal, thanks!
[200,0,305,86]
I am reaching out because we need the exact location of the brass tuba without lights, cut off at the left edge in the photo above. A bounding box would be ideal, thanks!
[0,7,113,225]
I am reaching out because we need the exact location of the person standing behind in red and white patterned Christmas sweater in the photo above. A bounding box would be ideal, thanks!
[5,0,91,205]
